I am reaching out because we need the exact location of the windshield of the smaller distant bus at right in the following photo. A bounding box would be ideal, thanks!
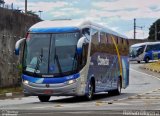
[130,46,145,57]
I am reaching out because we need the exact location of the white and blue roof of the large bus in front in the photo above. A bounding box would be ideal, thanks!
[29,20,127,38]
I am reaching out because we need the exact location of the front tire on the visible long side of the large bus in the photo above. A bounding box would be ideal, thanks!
[86,79,94,100]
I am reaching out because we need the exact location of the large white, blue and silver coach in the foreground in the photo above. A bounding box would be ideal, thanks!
[15,20,129,102]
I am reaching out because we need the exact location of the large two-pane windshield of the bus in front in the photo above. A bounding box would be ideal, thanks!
[23,32,80,77]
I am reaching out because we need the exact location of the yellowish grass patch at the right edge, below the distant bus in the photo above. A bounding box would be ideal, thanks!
[144,60,160,72]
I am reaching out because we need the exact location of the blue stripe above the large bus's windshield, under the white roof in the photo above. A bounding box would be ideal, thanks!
[29,27,79,33]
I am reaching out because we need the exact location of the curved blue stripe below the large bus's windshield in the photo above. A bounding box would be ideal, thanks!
[22,73,80,84]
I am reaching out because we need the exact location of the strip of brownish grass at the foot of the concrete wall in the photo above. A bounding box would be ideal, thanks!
[0,87,22,94]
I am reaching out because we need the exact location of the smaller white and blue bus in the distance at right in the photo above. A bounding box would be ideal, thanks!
[130,42,160,63]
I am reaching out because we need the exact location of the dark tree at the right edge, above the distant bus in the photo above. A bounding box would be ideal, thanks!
[148,19,160,40]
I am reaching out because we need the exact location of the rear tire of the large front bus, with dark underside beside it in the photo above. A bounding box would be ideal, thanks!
[108,78,122,95]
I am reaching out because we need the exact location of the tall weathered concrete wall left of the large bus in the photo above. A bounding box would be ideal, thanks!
[0,8,40,87]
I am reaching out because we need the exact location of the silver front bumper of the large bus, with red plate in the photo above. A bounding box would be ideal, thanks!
[23,81,85,96]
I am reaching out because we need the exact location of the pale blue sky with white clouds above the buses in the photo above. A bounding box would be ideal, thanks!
[4,0,160,39]
